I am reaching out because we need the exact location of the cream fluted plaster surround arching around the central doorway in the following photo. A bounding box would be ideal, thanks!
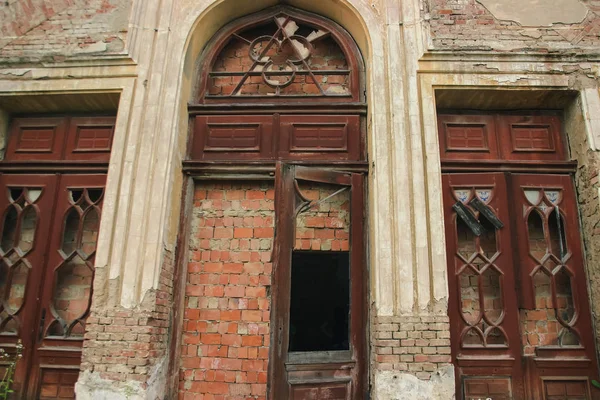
[69,0,454,399]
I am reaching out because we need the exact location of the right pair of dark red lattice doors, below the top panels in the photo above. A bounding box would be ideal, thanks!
[443,173,598,400]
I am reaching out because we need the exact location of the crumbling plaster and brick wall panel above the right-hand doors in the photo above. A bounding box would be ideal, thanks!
[423,0,600,54]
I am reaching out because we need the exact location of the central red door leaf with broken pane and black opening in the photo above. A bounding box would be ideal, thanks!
[269,163,367,400]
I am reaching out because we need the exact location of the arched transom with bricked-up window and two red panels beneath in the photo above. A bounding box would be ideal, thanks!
[188,7,366,163]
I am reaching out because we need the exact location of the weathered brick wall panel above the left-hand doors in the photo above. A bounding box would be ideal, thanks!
[0,0,130,62]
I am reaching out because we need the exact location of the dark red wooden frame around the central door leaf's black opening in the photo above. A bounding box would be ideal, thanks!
[267,162,368,399]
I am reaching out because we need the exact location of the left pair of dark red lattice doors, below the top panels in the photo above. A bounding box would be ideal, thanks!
[0,175,106,399]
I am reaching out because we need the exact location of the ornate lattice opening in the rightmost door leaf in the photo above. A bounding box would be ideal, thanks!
[515,177,586,354]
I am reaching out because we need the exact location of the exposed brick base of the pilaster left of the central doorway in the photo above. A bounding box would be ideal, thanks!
[75,276,171,400]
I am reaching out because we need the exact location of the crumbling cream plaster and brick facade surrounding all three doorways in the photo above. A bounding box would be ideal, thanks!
[0,0,600,400]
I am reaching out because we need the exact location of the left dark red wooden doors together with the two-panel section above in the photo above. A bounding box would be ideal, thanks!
[0,116,115,399]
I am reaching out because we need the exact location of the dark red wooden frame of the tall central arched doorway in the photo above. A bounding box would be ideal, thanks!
[168,5,369,399]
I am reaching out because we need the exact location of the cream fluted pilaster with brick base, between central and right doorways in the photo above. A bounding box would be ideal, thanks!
[371,0,454,400]
